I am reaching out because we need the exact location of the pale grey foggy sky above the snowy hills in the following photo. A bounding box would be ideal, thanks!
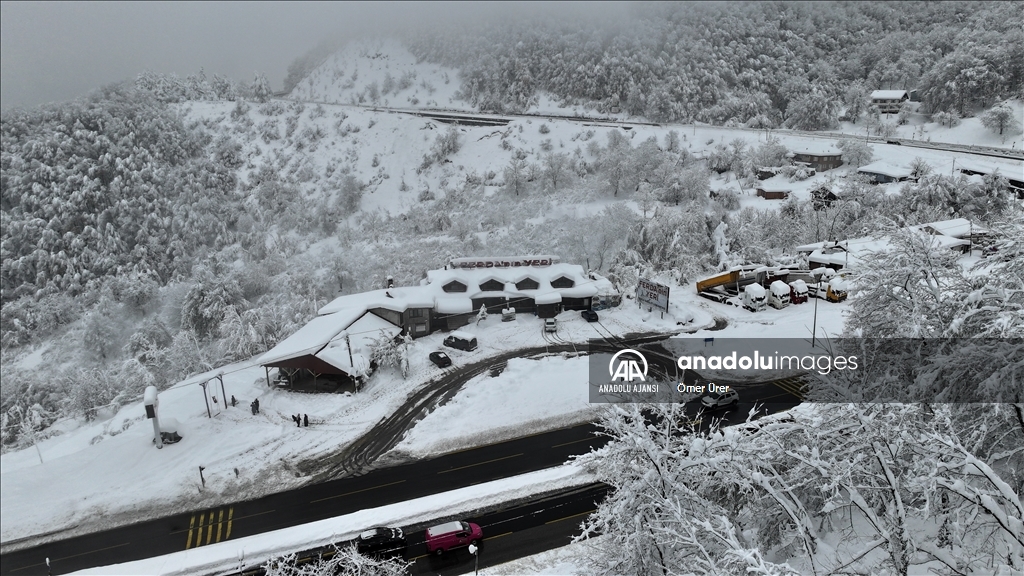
[0,1,626,110]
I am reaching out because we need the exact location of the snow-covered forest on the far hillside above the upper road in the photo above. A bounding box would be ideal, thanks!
[401,2,1024,119]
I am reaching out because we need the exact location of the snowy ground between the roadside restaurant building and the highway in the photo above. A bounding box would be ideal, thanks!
[0,304,696,552]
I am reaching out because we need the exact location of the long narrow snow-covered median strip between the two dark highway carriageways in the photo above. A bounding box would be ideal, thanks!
[74,465,594,576]
